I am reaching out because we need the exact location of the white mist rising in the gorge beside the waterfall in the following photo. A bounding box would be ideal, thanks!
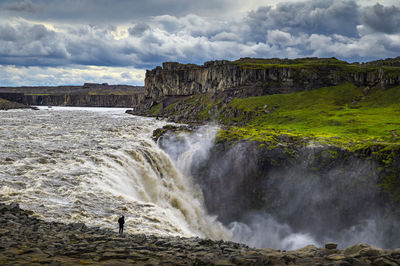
[159,126,400,250]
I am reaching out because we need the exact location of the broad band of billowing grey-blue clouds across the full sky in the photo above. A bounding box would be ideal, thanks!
[0,0,400,74]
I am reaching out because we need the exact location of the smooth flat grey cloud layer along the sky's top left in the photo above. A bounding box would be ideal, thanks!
[0,0,243,24]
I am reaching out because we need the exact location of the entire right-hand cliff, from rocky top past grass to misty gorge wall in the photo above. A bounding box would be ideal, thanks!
[145,58,400,247]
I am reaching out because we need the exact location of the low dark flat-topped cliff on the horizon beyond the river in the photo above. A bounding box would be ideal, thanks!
[0,83,144,107]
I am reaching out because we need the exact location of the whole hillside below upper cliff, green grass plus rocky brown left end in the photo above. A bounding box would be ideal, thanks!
[150,83,400,149]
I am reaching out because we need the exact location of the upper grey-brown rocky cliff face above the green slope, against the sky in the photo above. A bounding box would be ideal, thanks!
[145,58,400,99]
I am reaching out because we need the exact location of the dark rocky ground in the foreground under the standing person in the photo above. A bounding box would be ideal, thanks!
[0,203,400,266]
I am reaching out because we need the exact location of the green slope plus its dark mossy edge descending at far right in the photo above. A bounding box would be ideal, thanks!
[214,83,400,201]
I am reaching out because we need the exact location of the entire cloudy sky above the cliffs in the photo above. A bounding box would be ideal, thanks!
[0,0,400,86]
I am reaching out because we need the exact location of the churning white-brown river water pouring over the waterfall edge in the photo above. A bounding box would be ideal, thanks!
[0,107,230,239]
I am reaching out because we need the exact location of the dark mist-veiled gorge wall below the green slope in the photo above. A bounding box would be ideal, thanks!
[155,127,400,248]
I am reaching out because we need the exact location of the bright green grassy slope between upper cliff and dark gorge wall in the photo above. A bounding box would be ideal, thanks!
[220,84,400,148]
